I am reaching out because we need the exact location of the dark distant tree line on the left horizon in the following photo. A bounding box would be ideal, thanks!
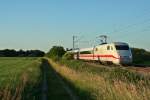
[0,49,45,57]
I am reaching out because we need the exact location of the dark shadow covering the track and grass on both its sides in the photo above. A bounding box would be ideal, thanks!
[16,58,94,100]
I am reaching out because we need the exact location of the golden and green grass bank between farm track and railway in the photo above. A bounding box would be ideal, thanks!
[50,60,150,100]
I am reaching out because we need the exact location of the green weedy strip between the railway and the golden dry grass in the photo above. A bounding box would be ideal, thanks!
[59,60,150,84]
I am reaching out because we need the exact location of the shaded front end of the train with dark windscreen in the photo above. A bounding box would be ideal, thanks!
[115,43,132,65]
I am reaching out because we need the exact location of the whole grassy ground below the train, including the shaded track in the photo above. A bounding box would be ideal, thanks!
[0,57,150,100]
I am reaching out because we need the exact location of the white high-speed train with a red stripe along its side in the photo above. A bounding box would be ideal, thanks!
[74,42,132,65]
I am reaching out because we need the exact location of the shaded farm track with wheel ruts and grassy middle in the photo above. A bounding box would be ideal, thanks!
[42,59,78,100]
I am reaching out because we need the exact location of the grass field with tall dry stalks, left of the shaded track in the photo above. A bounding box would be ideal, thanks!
[0,57,41,100]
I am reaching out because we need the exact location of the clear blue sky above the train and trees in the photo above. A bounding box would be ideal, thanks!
[0,0,150,52]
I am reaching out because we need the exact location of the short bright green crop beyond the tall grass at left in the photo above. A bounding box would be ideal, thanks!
[0,58,39,88]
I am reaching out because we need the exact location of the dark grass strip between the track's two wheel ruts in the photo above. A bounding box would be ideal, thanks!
[42,59,71,100]
